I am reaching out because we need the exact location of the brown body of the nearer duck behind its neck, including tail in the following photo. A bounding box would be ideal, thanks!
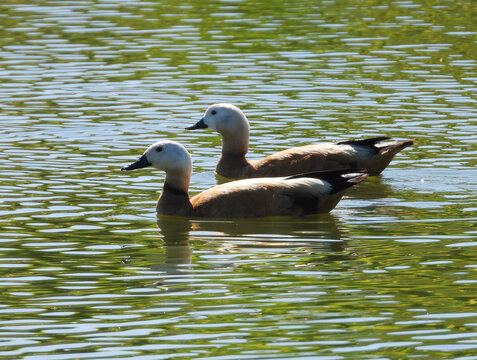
[190,170,368,218]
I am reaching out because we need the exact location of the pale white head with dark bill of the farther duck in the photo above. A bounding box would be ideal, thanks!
[186,103,250,154]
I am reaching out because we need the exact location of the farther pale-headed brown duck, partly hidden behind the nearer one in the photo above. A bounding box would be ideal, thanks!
[186,103,415,179]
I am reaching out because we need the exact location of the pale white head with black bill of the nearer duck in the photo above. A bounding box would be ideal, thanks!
[121,140,192,189]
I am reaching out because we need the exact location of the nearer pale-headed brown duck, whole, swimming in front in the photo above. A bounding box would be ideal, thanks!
[121,140,368,218]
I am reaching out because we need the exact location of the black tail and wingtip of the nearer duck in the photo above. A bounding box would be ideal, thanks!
[286,169,369,194]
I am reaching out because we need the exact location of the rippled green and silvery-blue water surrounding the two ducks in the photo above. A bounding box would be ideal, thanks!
[0,0,477,360]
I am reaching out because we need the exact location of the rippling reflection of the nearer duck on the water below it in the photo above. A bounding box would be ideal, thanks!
[149,214,356,292]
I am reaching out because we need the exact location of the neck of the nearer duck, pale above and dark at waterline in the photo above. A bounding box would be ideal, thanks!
[156,174,192,216]
